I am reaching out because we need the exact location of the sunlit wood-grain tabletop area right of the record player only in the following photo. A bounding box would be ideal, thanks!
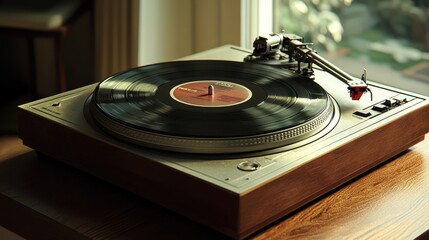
[254,139,429,239]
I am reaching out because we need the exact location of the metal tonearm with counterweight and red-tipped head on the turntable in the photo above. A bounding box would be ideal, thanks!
[245,34,370,100]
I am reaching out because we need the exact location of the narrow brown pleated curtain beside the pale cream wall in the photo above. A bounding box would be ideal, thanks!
[94,0,139,81]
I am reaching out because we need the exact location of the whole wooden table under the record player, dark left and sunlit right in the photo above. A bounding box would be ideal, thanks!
[0,135,429,239]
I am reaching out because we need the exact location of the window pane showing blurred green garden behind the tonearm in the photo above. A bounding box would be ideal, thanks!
[273,0,429,95]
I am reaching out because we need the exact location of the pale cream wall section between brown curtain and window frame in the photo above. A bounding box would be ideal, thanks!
[139,0,241,65]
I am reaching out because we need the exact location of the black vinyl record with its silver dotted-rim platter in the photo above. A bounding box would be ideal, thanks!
[91,60,333,153]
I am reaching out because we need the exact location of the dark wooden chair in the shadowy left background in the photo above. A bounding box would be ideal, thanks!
[0,0,91,98]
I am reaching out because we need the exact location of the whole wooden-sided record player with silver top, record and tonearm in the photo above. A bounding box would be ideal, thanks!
[18,34,429,239]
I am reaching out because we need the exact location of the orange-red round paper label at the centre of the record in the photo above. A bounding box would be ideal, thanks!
[170,80,252,107]
